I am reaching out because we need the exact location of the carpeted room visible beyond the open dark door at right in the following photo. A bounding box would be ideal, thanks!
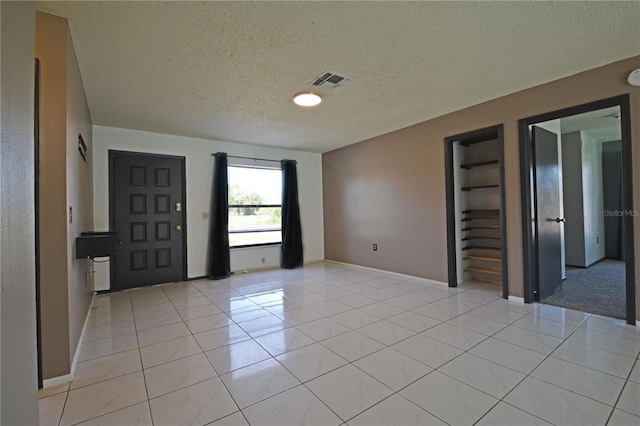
[536,106,626,319]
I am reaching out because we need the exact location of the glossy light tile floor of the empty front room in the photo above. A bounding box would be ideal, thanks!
[40,263,640,426]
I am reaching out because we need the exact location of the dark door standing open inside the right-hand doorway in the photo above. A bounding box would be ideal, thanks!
[532,126,564,300]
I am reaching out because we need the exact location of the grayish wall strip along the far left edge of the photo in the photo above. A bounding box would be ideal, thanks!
[0,1,38,425]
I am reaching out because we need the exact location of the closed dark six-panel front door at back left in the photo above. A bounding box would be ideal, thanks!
[109,151,186,290]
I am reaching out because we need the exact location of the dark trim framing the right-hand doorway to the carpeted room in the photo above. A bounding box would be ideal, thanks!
[518,94,636,325]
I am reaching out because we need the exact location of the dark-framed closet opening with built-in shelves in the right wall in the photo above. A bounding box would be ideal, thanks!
[444,125,509,299]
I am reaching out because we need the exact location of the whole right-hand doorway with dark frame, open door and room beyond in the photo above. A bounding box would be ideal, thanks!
[520,96,635,324]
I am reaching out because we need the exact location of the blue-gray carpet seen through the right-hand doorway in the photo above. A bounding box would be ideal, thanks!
[542,259,627,319]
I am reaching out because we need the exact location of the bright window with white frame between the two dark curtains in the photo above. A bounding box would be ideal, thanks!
[227,166,282,248]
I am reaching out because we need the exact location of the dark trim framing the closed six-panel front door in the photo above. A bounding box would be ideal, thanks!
[108,149,188,292]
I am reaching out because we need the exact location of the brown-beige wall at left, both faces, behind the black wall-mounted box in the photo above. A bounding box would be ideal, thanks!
[36,12,93,379]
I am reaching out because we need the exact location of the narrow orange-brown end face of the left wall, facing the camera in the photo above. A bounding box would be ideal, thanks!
[36,13,71,379]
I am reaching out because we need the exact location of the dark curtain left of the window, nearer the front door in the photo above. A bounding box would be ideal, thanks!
[209,152,231,280]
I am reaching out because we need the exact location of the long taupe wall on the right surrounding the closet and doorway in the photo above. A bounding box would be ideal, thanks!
[323,56,640,317]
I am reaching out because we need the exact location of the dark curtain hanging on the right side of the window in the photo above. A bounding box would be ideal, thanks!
[280,160,303,269]
